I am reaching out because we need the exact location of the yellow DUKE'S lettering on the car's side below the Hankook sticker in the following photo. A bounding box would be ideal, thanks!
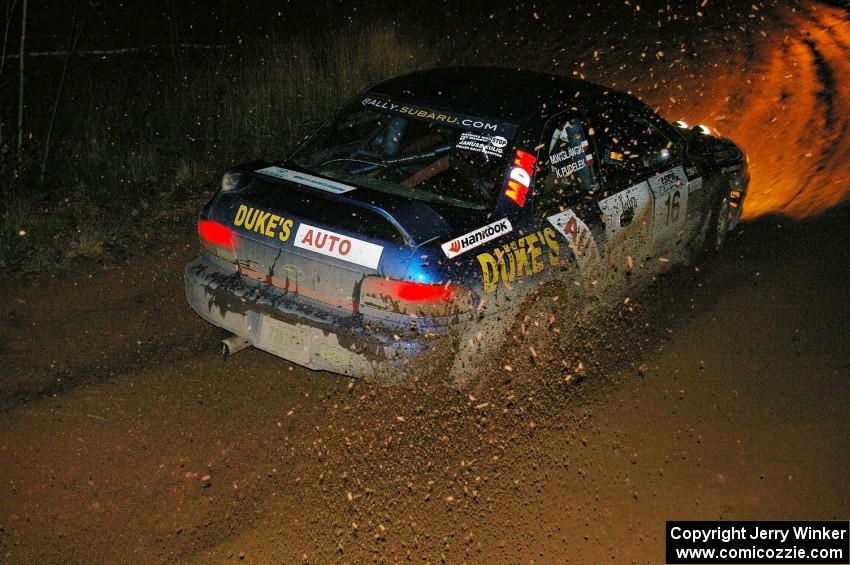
[477,227,561,293]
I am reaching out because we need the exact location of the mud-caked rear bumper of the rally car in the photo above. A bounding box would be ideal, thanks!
[185,256,456,382]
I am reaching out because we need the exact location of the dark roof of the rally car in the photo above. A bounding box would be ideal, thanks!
[369,67,635,123]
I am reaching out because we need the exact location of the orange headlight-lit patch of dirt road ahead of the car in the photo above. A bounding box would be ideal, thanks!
[672,4,850,219]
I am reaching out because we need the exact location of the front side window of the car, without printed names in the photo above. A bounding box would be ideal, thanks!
[595,107,678,184]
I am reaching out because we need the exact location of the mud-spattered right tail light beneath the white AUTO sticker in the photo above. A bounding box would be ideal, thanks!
[360,276,472,318]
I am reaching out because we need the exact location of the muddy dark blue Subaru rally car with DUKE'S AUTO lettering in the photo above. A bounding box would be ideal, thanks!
[185,67,748,381]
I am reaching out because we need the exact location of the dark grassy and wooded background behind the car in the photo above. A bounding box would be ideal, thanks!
[0,0,773,272]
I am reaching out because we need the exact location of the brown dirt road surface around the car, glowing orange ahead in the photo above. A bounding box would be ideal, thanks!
[0,4,850,563]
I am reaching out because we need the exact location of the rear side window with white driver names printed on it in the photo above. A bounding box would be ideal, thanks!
[538,116,599,209]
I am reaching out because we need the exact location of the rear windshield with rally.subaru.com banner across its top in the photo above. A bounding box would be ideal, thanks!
[290,95,517,209]
